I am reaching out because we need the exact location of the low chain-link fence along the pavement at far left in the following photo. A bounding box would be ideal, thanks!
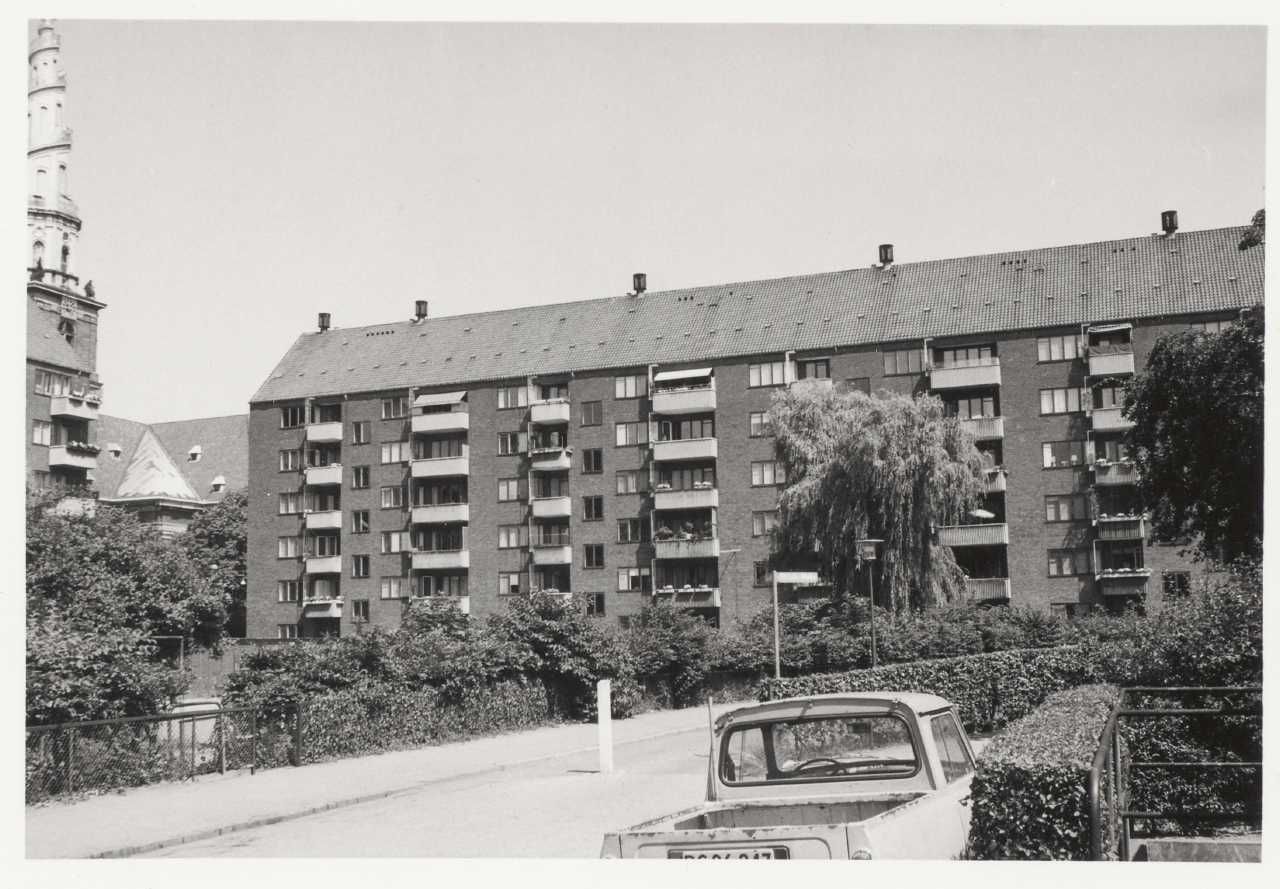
[27,707,301,805]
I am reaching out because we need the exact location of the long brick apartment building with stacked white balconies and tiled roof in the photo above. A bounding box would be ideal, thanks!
[248,221,1263,637]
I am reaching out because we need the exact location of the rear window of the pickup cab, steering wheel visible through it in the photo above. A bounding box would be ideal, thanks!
[721,714,919,784]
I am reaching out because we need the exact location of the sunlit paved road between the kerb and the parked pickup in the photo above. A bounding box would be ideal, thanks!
[145,728,707,858]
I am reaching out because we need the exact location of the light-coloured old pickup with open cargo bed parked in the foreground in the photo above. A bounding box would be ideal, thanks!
[600,692,974,860]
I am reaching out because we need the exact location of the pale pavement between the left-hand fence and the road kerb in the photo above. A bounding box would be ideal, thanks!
[27,705,739,858]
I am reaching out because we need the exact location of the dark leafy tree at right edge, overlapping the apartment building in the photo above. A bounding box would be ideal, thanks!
[1124,306,1265,562]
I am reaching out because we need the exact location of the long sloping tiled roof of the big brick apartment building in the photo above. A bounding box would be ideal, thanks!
[251,226,1263,403]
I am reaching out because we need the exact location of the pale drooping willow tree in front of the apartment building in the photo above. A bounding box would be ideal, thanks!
[769,388,984,613]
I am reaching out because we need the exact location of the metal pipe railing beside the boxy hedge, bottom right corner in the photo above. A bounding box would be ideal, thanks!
[1088,686,1262,861]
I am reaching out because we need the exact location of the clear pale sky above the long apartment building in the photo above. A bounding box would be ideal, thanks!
[42,19,1266,422]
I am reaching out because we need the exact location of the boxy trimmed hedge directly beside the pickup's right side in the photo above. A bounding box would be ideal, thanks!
[969,686,1120,861]
